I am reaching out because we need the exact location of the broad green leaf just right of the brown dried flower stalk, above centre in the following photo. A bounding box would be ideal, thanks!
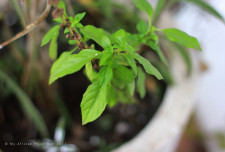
[81,25,111,49]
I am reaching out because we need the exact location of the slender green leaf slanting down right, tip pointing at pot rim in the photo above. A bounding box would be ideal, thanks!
[134,53,163,80]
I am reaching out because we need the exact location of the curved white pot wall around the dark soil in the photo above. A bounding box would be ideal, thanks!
[113,50,200,152]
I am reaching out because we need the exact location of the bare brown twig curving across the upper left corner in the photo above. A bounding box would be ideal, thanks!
[0,0,52,49]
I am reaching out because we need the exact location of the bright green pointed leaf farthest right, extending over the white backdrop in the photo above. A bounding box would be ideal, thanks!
[163,28,201,50]
